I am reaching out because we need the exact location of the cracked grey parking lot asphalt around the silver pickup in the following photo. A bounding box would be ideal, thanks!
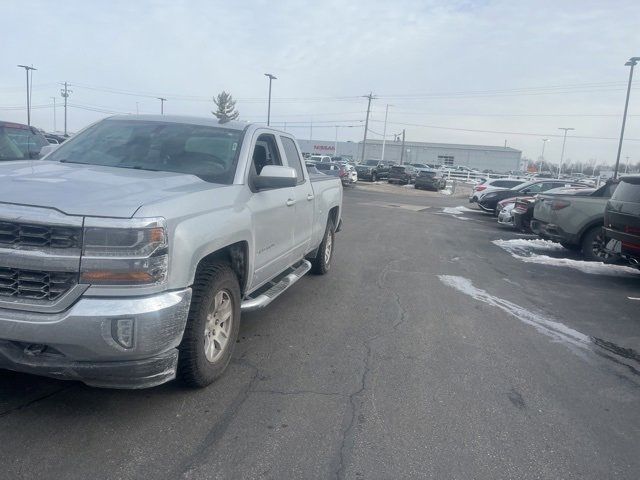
[0,182,640,479]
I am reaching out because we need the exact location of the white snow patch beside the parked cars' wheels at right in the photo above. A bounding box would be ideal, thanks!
[492,238,640,276]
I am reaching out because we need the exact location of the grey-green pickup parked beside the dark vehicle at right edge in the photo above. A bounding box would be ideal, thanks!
[531,181,618,260]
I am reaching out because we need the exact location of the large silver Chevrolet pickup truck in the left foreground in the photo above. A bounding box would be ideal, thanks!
[0,116,342,388]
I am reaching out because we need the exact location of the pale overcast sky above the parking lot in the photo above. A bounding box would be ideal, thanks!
[0,0,640,163]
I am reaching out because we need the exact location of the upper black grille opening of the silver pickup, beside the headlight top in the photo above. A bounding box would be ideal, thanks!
[0,221,82,248]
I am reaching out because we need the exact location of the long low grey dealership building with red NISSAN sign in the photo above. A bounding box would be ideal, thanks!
[299,140,522,172]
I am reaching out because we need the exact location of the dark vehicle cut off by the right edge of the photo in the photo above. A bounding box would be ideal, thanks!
[603,175,640,268]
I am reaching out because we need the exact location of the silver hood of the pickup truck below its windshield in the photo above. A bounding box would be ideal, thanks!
[0,160,221,218]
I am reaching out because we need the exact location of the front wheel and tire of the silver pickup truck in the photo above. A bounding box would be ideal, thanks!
[178,262,241,388]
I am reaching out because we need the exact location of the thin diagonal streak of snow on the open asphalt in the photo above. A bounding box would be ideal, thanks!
[438,275,591,349]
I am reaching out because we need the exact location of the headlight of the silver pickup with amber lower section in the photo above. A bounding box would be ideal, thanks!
[80,218,169,286]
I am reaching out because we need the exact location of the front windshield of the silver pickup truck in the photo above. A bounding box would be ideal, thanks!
[47,120,242,184]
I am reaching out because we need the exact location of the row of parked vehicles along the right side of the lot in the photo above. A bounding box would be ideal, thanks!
[469,175,640,268]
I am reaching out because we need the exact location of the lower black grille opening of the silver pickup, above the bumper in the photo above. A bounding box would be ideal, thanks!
[0,267,78,301]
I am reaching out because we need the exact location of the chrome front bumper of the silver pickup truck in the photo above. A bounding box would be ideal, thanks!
[0,289,191,388]
